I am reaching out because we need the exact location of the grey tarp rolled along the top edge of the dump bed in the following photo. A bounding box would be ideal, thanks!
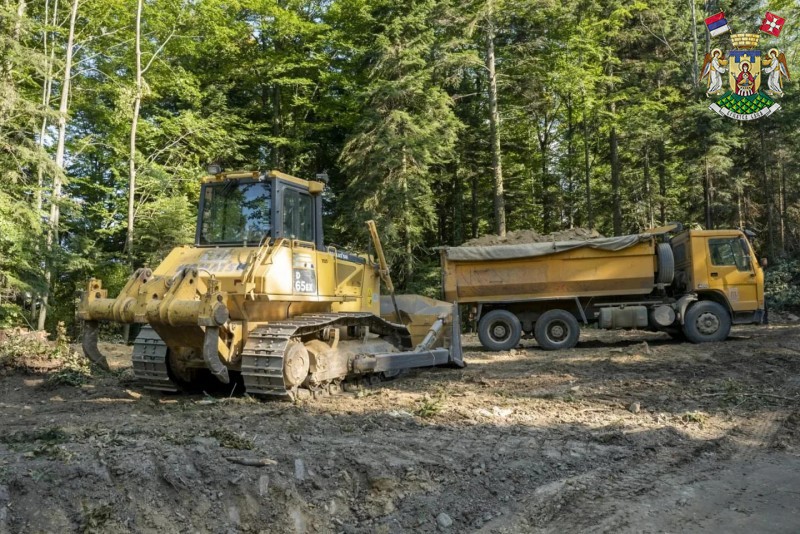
[444,234,653,261]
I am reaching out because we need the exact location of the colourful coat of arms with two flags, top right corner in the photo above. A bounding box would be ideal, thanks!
[700,12,790,121]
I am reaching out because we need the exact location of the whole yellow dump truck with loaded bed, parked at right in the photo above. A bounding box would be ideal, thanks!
[441,225,764,350]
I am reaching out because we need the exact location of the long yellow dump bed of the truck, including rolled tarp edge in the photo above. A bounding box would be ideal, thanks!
[441,234,658,303]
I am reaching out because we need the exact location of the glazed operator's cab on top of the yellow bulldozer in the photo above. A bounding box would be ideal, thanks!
[195,171,325,250]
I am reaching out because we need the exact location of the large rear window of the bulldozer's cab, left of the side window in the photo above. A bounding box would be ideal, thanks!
[199,180,272,245]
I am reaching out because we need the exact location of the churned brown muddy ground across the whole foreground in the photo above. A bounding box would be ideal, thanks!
[0,325,800,533]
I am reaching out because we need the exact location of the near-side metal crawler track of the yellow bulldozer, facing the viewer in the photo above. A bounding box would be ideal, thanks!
[242,312,411,398]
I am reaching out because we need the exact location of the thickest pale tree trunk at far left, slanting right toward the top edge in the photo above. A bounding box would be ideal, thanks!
[38,0,78,330]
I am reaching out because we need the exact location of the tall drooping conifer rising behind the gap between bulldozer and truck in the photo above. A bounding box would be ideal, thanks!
[341,0,461,283]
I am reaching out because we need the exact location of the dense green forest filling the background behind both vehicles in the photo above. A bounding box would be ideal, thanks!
[0,0,800,331]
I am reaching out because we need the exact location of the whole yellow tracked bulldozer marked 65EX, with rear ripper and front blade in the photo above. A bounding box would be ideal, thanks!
[77,169,464,399]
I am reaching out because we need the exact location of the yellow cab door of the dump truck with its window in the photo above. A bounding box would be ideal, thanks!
[707,236,759,311]
